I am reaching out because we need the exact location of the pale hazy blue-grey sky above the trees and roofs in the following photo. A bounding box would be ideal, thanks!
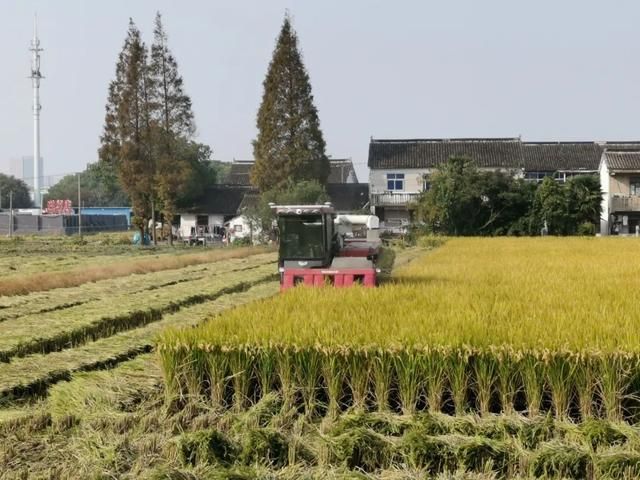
[0,0,640,181]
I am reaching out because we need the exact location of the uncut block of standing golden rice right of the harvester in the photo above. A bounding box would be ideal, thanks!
[159,238,640,419]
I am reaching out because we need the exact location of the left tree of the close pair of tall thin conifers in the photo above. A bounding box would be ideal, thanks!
[99,20,155,242]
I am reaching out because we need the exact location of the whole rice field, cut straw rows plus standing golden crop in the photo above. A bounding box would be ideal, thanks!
[6,238,640,480]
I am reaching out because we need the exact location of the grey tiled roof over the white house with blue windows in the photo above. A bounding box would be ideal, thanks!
[368,138,522,168]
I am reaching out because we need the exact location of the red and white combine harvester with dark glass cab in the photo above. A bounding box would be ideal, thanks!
[271,202,380,290]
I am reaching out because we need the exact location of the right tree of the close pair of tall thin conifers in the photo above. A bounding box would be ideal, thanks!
[149,13,195,243]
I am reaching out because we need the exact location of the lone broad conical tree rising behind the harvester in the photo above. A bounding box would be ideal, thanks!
[251,15,329,192]
